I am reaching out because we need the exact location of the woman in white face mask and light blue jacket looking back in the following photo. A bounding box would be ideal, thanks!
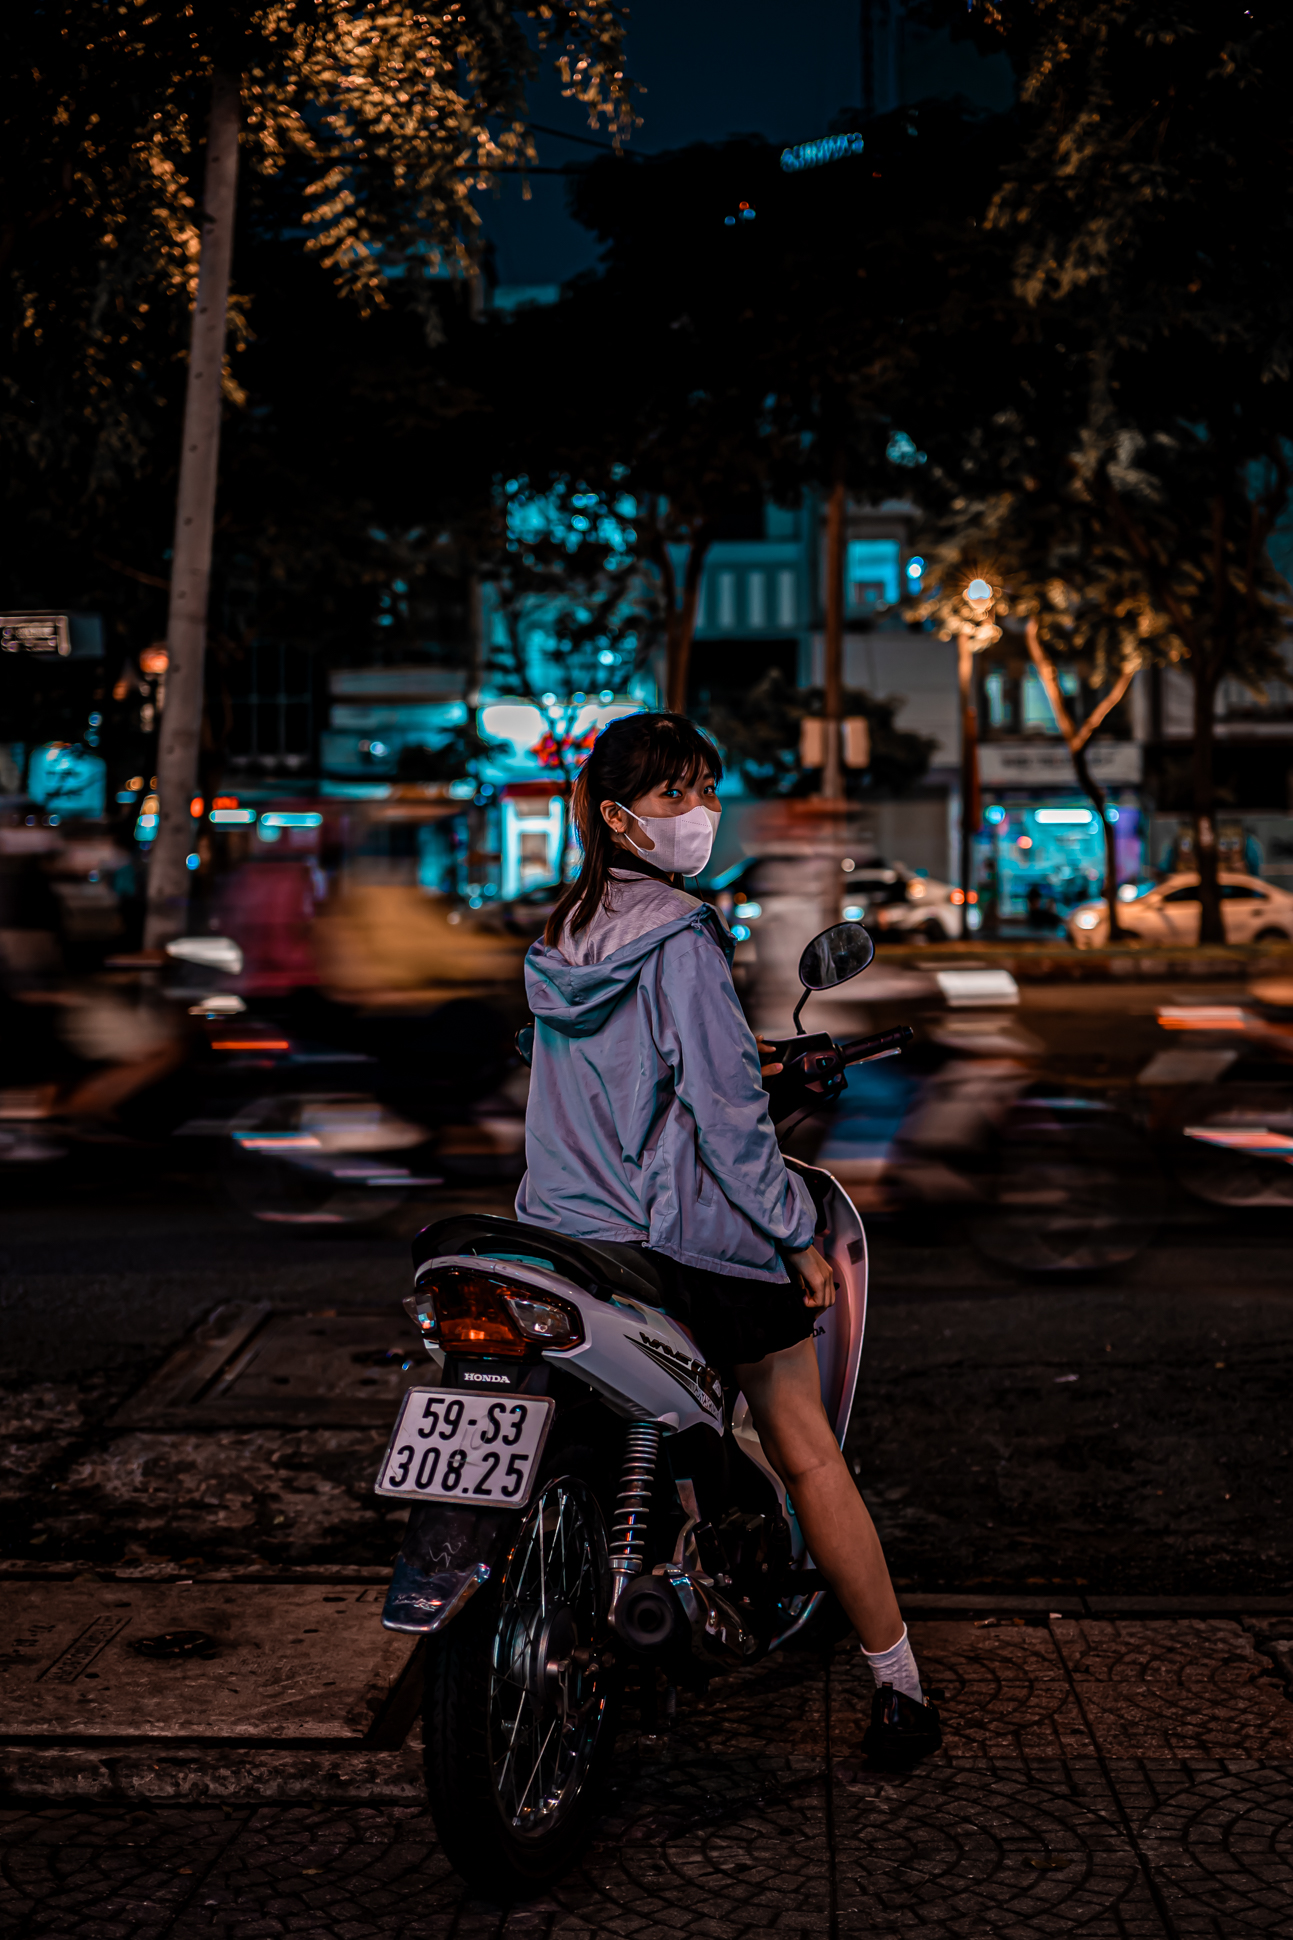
[516,714,940,1762]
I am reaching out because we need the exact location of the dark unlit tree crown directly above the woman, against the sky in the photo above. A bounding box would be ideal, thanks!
[485,115,1013,675]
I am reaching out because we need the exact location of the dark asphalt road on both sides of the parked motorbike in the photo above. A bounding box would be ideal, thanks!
[0,1150,1293,1595]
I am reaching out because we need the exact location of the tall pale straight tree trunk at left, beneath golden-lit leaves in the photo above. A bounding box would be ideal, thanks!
[144,72,239,949]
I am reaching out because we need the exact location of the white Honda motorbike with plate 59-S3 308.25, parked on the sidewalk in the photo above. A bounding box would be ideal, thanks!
[377,923,912,1897]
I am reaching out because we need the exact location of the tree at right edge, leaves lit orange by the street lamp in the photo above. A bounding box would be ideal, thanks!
[912,0,1293,941]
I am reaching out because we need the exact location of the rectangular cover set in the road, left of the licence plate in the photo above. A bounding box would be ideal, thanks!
[113,1306,437,1430]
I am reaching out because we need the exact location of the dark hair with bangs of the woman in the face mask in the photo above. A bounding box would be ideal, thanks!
[544,714,722,949]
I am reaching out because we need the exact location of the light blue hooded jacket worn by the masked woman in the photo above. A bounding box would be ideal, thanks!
[516,896,815,1280]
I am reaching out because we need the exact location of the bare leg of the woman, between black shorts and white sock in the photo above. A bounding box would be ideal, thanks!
[736,1341,903,1651]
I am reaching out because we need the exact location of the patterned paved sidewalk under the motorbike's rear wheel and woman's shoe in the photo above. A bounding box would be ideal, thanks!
[0,1618,1293,1940]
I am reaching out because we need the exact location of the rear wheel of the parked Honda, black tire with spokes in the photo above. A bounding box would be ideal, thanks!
[423,1457,619,1901]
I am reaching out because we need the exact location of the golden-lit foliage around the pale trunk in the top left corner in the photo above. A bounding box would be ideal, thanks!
[0,0,633,625]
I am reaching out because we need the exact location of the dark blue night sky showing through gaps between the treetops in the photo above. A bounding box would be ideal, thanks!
[481,0,1011,283]
